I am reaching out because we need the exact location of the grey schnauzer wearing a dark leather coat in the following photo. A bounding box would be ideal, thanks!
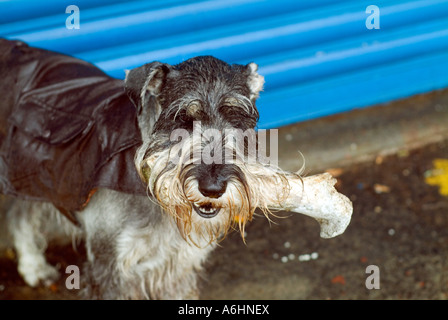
[0,40,294,299]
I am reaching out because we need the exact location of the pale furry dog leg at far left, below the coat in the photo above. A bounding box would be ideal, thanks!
[7,200,59,287]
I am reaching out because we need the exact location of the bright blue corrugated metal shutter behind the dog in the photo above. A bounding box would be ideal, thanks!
[0,0,448,128]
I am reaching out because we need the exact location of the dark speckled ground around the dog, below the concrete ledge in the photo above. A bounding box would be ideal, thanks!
[0,136,448,300]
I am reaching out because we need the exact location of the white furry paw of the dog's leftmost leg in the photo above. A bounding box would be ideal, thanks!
[18,256,60,287]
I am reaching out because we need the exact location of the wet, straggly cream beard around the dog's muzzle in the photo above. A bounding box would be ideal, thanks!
[136,131,300,246]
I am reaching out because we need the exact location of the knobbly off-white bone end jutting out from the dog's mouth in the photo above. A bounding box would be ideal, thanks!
[264,173,353,238]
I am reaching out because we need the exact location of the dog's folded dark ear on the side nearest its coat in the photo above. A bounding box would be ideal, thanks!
[124,61,171,116]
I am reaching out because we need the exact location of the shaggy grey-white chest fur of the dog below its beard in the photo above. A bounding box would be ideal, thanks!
[79,189,213,299]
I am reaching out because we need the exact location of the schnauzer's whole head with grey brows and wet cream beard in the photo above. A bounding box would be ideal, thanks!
[125,57,264,244]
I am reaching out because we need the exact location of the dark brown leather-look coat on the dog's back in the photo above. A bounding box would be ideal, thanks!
[0,39,146,219]
